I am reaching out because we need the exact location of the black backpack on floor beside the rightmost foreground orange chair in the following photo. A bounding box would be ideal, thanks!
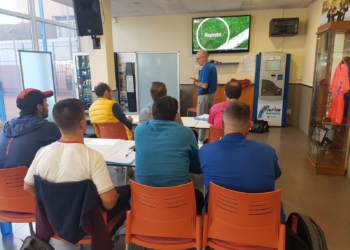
[287,213,328,250]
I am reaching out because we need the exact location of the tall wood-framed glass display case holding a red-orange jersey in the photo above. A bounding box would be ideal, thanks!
[306,21,350,175]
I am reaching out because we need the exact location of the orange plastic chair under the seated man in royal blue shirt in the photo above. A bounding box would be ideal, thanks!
[203,182,286,250]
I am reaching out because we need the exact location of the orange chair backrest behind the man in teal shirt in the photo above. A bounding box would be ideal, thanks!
[127,180,196,239]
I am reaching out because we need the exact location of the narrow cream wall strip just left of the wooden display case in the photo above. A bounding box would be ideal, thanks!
[302,0,323,86]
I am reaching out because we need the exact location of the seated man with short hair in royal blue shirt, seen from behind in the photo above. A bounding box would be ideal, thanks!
[199,100,285,223]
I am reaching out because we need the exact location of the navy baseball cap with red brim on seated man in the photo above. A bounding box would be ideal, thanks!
[16,88,53,110]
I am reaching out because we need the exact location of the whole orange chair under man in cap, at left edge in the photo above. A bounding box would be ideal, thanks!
[0,166,35,233]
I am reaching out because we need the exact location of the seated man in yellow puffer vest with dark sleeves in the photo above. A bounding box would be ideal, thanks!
[89,82,133,140]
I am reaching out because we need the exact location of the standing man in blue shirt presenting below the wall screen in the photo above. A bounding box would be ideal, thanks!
[190,50,218,143]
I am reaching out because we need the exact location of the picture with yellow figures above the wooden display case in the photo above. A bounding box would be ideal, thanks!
[320,0,350,25]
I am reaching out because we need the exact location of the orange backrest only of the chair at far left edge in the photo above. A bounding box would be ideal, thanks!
[0,166,35,213]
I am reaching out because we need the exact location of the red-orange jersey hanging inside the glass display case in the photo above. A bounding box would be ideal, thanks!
[329,63,349,124]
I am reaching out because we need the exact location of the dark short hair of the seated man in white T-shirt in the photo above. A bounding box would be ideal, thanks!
[52,98,85,131]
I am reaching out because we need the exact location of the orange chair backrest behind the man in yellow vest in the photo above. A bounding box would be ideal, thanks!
[94,122,128,140]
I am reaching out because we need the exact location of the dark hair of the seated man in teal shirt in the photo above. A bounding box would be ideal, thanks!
[152,96,179,121]
